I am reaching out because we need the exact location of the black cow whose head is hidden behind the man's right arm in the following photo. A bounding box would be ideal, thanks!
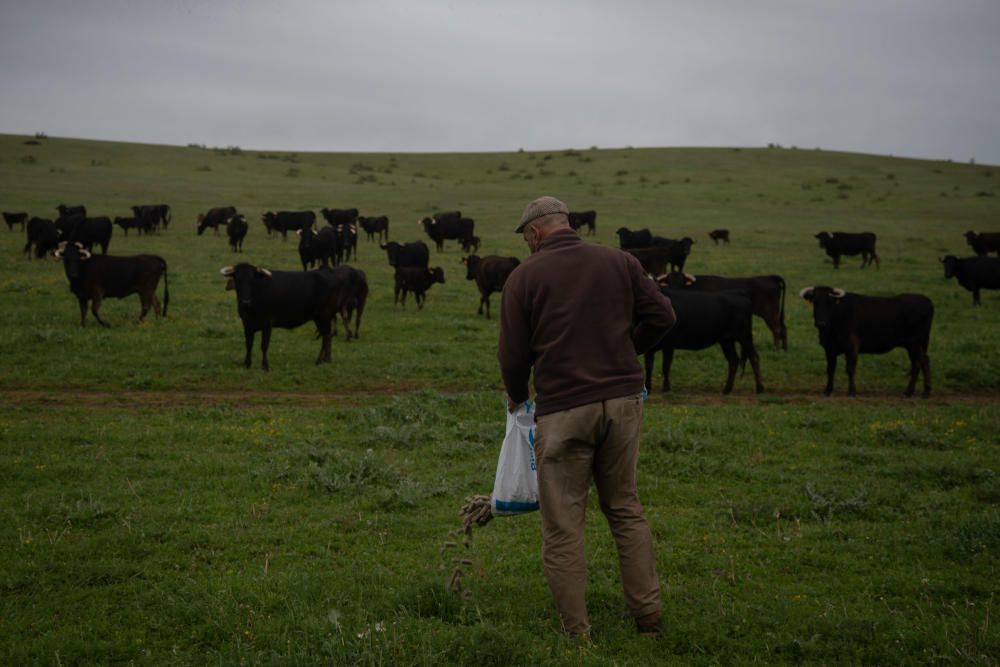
[644,288,764,394]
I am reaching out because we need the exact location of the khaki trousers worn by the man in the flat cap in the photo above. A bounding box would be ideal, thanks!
[535,394,660,634]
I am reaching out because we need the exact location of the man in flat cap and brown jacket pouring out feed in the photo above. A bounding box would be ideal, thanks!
[497,197,676,639]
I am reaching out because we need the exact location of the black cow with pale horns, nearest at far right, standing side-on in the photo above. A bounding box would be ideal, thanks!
[799,286,934,398]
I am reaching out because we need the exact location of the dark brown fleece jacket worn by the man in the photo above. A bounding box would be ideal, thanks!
[497,227,676,415]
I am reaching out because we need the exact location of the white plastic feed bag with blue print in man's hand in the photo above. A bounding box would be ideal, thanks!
[491,401,538,516]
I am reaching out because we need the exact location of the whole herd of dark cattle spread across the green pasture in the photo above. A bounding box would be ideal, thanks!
[3,204,1000,397]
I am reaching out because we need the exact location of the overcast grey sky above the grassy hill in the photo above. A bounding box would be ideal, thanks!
[0,0,1000,164]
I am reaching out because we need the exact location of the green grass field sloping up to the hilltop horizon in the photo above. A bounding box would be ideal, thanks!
[0,135,1000,665]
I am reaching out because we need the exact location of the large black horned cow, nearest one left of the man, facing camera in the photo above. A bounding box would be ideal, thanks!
[220,263,337,371]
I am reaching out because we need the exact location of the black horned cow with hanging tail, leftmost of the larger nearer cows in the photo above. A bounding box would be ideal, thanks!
[56,242,170,327]
